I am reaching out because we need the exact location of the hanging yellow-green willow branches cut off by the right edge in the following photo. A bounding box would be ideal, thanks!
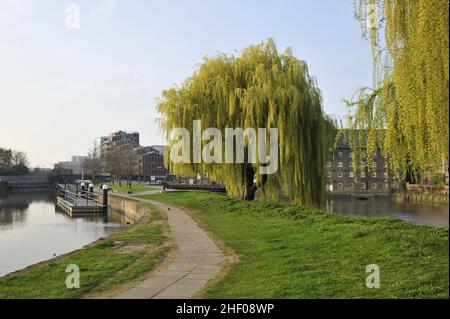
[348,0,449,180]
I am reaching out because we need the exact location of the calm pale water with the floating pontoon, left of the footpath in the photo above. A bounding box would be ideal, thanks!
[0,193,123,277]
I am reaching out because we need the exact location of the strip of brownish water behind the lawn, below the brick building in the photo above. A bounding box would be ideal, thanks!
[327,199,449,227]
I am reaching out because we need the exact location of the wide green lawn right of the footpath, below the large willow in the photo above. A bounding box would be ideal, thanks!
[142,192,449,298]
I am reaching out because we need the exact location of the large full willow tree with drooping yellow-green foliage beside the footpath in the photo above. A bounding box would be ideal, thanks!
[157,39,334,206]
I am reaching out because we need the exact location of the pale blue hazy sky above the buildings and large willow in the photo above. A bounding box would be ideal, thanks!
[0,0,372,167]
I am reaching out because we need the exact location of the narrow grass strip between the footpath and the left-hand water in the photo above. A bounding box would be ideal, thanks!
[0,202,172,299]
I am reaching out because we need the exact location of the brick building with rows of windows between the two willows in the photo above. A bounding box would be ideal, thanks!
[326,138,397,193]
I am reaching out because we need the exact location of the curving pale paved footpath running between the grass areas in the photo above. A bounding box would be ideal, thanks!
[115,191,229,299]
